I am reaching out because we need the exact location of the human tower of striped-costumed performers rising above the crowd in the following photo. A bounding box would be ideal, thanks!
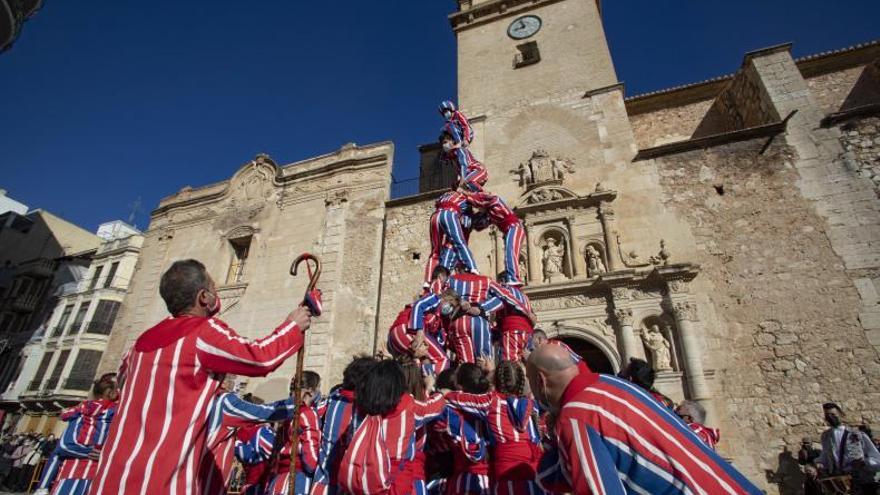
[388,101,536,374]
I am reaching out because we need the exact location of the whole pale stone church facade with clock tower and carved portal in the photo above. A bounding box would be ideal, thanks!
[101,0,880,490]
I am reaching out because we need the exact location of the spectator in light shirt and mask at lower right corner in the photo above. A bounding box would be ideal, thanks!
[817,402,880,495]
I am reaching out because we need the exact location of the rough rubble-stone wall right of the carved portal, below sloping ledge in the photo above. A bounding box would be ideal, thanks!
[654,139,880,492]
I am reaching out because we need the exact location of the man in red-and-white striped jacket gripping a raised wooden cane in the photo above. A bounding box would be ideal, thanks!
[89,260,311,495]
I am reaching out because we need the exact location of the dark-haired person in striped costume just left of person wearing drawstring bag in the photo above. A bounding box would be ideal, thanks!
[312,356,376,495]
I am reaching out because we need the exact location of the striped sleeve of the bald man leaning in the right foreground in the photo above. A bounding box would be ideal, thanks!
[556,415,626,495]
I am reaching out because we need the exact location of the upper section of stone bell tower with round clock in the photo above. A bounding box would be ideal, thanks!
[450,0,617,112]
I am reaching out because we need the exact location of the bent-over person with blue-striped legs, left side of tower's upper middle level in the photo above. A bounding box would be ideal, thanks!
[425,189,478,284]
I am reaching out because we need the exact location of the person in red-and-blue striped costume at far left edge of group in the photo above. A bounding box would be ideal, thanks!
[35,373,119,495]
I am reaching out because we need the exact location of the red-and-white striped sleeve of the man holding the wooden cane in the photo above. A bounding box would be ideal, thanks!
[196,318,303,376]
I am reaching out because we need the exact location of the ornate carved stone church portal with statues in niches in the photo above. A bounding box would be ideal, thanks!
[508,150,709,408]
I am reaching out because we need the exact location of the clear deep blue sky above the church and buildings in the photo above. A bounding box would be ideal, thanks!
[0,0,880,229]
